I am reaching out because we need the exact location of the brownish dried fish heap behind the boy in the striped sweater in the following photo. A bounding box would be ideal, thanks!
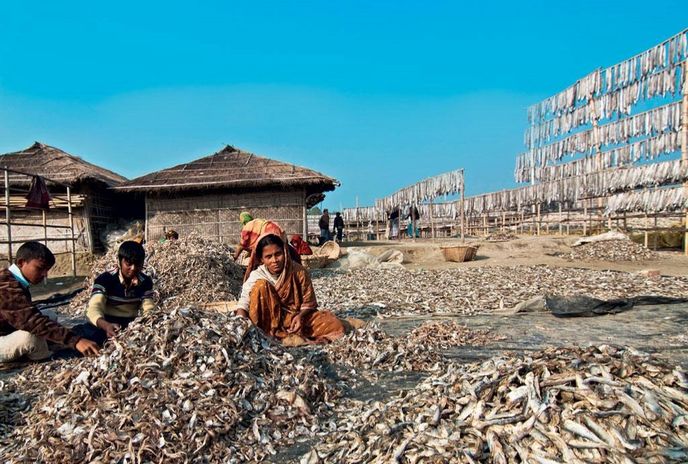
[69,237,244,314]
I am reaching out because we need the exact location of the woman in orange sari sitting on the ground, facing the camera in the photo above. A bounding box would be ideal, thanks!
[237,234,344,343]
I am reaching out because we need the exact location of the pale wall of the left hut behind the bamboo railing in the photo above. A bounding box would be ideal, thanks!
[0,207,91,257]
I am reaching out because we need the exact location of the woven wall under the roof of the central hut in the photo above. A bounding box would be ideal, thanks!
[146,191,305,243]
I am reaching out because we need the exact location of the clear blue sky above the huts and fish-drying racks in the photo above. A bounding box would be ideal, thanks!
[0,0,688,209]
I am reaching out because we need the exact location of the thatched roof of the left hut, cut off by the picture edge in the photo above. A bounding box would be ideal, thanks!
[0,142,127,187]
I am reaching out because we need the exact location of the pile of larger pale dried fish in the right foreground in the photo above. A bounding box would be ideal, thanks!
[310,346,688,463]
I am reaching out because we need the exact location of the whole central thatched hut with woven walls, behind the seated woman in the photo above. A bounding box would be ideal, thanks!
[114,145,338,243]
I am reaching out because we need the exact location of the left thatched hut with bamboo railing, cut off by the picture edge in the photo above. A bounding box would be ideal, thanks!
[0,142,127,254]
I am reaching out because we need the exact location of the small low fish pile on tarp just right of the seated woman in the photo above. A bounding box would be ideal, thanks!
[322,321,499,372]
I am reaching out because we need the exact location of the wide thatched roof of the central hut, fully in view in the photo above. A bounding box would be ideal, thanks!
[116,145,339,194]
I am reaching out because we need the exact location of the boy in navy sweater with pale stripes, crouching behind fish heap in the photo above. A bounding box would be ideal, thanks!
[80,241,155,345]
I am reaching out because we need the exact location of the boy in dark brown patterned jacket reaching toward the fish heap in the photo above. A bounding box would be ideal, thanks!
[0,242,98,362]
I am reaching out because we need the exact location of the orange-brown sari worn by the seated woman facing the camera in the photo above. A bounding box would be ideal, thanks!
[248,237,345,343]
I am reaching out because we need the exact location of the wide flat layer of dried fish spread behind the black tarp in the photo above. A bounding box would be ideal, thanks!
[313,266,688,317]
